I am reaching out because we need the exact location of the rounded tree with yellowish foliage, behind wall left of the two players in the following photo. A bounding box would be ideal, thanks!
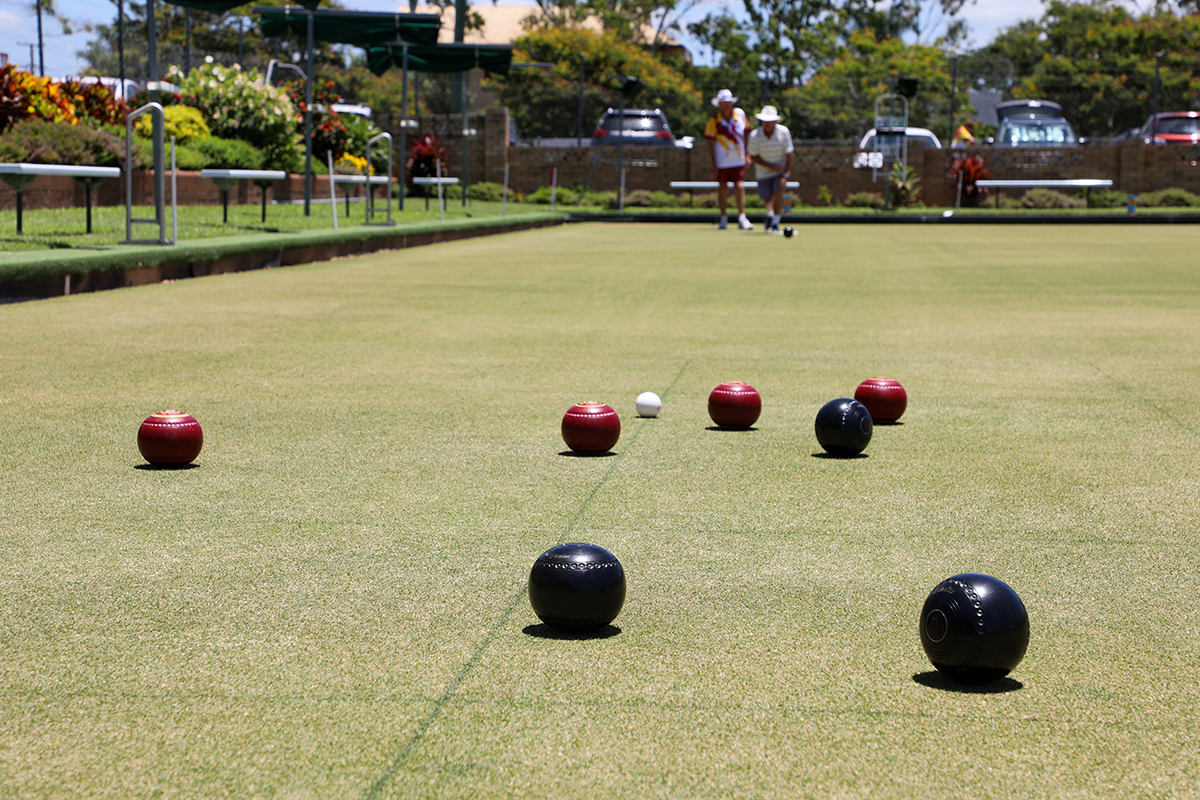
[485,26,708,137]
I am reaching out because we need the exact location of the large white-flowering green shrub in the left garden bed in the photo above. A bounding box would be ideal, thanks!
[167,64,301,170]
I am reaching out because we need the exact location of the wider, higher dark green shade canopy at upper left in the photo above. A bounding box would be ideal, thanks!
[256,0,442,47]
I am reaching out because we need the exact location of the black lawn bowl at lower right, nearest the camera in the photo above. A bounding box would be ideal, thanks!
[920,573,1030,685]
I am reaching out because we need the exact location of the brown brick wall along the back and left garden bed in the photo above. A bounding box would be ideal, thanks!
[0,108,1200,209]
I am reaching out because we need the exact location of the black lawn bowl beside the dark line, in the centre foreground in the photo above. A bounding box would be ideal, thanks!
[529,542,625,633]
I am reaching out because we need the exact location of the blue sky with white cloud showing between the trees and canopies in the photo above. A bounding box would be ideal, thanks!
[0,0,1042,78]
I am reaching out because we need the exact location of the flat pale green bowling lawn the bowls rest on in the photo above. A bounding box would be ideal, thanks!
[0,224,1200,799]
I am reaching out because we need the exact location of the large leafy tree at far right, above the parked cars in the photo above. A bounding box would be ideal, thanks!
[965,0,1200,136]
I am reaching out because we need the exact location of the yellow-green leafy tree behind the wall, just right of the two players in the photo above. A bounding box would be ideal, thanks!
[780,31,972,142]
